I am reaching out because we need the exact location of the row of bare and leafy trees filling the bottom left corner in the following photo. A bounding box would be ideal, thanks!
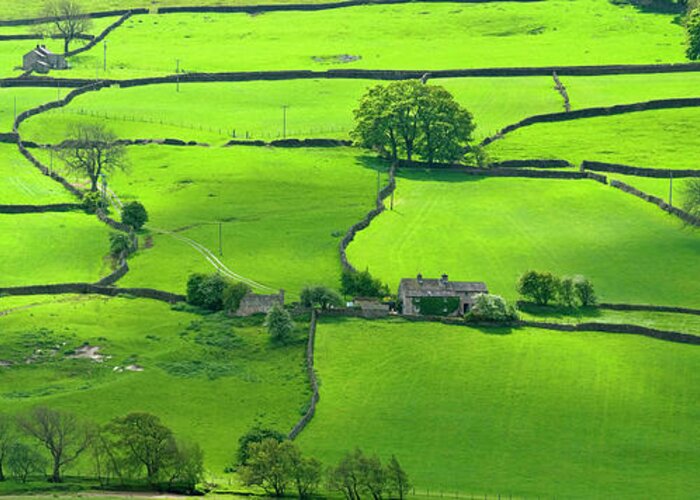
[0,407,204,492]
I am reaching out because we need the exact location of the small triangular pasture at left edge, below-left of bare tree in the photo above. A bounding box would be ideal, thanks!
[0,144,76,205]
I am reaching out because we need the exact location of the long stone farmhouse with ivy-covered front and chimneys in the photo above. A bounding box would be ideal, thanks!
[399,274,488,316]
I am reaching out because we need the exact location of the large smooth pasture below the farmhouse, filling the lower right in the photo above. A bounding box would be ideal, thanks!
[300,319,700,498]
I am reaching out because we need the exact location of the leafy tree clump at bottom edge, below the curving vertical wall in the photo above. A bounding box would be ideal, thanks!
[238,427,411,500]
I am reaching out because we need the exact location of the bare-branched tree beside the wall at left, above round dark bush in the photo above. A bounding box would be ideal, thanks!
[59,123,127,192]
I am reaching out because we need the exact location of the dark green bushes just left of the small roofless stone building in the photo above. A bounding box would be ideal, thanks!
[187,273,252,312]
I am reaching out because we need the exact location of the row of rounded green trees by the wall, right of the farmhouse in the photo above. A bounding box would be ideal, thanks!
[517,271,597,307]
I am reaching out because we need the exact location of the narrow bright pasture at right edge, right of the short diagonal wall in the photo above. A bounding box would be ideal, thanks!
[561,73,700,109]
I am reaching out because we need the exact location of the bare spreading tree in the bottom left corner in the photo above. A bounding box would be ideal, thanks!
[18,407,92,483]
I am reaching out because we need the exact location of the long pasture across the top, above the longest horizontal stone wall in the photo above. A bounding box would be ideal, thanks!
[63,0,685,78]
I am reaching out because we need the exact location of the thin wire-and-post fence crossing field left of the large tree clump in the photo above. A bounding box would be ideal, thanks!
[58,108,349,139]
